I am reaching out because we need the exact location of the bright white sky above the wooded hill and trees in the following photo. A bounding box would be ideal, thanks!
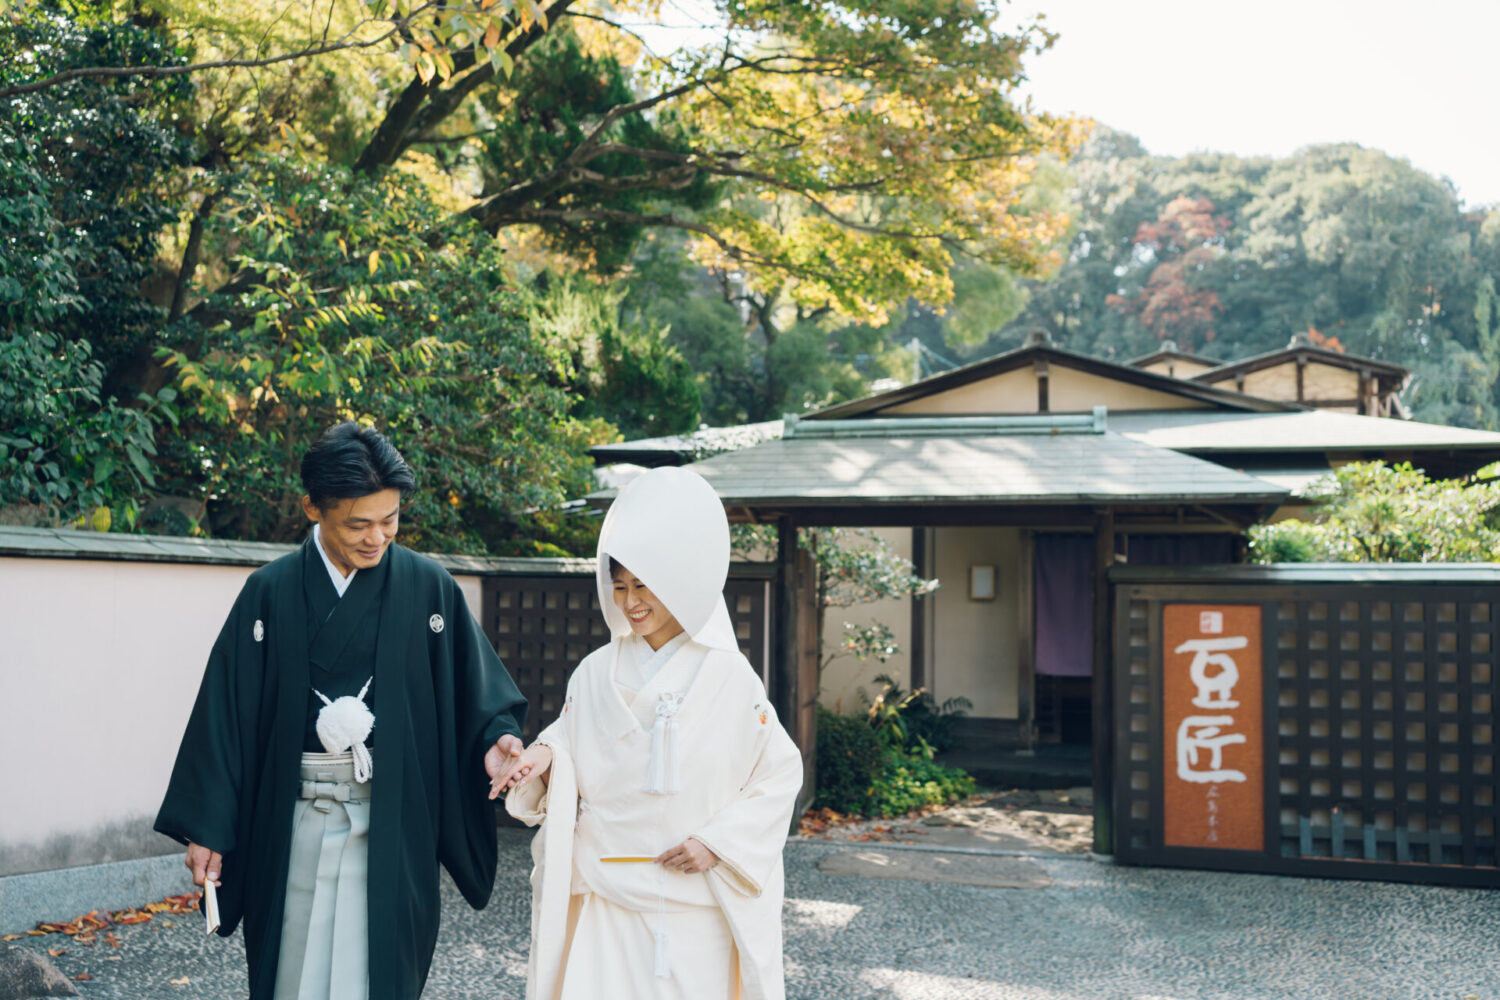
[639,0,1500,207]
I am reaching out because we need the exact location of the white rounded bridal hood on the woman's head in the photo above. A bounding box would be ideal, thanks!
[597,468,740,652]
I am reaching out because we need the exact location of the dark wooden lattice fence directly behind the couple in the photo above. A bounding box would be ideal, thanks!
[483,573,773,741]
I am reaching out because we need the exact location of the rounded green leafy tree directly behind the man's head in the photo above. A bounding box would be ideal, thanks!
[152,157,599,552]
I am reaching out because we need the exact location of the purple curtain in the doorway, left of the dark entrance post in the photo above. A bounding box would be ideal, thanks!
[1037,534,1094,678]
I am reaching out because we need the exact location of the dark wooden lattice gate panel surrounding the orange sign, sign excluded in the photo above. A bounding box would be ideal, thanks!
[1113,585,1500,886]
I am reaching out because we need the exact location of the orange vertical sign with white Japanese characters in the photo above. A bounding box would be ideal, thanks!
[1161,604,1266,850]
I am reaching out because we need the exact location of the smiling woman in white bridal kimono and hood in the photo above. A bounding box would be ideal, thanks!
[492,468,803,1000]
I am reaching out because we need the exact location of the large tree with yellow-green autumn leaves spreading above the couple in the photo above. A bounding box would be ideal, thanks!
[17,0,1076,412]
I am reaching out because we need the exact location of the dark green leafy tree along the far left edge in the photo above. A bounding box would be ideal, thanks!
[0,10,193,523]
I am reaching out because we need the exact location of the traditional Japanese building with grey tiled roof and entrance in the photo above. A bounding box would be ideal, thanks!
[594,342,1500,881]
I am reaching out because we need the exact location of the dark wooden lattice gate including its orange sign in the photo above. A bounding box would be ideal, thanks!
[1110,564,1500,886]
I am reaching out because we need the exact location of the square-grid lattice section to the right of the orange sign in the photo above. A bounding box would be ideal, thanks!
[1266,592,1496,867]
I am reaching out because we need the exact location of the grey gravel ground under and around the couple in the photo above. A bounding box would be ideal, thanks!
[18,831,1500,1000]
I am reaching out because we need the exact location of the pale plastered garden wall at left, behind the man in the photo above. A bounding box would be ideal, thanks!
[0,558,480,876]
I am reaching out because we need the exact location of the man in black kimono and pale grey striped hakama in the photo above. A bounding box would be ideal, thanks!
[156,423,525,1000]
